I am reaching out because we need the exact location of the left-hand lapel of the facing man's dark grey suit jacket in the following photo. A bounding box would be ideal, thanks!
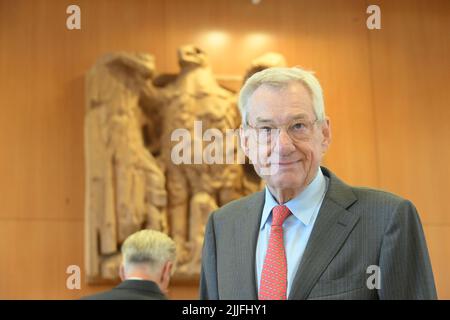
[232,192,264,300]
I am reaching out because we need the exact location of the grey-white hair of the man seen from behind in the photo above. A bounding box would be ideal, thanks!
[122,229,176,272]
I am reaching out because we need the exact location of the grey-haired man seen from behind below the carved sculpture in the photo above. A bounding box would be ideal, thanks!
[85,230,176,300]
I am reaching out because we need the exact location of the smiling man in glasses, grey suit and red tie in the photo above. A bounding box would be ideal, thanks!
[200,68,436,300]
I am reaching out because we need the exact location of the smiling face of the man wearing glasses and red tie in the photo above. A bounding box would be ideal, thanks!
[241,82,331,191]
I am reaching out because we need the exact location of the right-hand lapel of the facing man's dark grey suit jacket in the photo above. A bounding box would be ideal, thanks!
[289,167,359,299]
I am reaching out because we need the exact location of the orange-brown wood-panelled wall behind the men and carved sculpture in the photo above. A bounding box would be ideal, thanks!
[0,0,450,299]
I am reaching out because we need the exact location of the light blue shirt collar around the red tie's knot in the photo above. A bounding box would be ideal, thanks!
[260,167,327,230]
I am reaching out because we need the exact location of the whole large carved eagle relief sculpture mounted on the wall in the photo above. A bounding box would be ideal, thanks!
[85,45,285,282]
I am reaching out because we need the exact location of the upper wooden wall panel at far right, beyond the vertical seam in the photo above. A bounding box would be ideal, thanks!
[369,0,450,225]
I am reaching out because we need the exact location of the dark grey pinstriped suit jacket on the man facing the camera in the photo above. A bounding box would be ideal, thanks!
[200,167,437,300]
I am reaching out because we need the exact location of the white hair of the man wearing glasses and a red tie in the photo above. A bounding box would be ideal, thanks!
[239,67,325,125]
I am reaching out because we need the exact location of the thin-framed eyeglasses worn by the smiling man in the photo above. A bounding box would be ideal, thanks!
[246,119,320,145]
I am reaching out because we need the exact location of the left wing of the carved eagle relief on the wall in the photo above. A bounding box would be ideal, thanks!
[85,53,168,278]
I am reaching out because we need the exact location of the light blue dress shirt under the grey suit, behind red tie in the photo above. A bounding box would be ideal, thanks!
[256,167,328,296]
